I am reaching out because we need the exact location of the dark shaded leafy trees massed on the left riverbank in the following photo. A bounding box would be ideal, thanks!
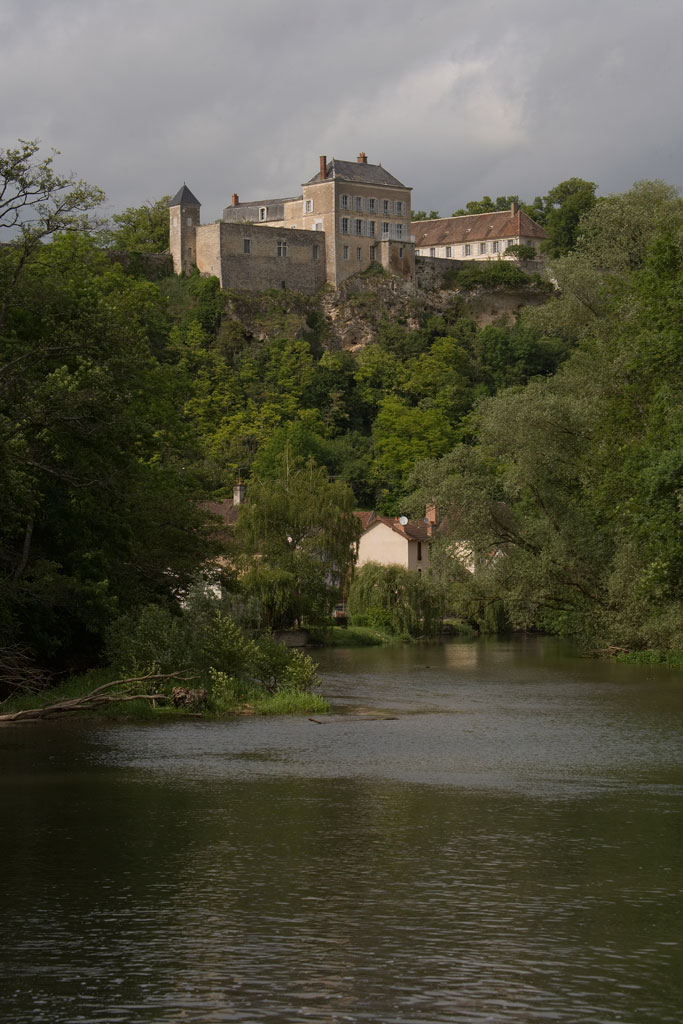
[0,233,209,668]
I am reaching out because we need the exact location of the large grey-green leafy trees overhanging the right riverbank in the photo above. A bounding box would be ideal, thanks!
[414,183,683,649]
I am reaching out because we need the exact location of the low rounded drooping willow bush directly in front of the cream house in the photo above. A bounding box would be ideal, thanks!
[347,562,443,636]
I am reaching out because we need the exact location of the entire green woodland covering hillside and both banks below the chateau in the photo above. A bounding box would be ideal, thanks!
[0,143,683,696]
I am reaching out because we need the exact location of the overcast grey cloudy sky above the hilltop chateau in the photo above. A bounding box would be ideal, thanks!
[0,0,683,221]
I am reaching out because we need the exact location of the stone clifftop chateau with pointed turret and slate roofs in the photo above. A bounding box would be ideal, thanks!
[169,153,415,293]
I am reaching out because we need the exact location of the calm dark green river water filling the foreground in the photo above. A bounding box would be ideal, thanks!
[0,640,683,1024]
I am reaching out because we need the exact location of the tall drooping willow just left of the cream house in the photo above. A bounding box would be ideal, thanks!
[236,452,360,629]
